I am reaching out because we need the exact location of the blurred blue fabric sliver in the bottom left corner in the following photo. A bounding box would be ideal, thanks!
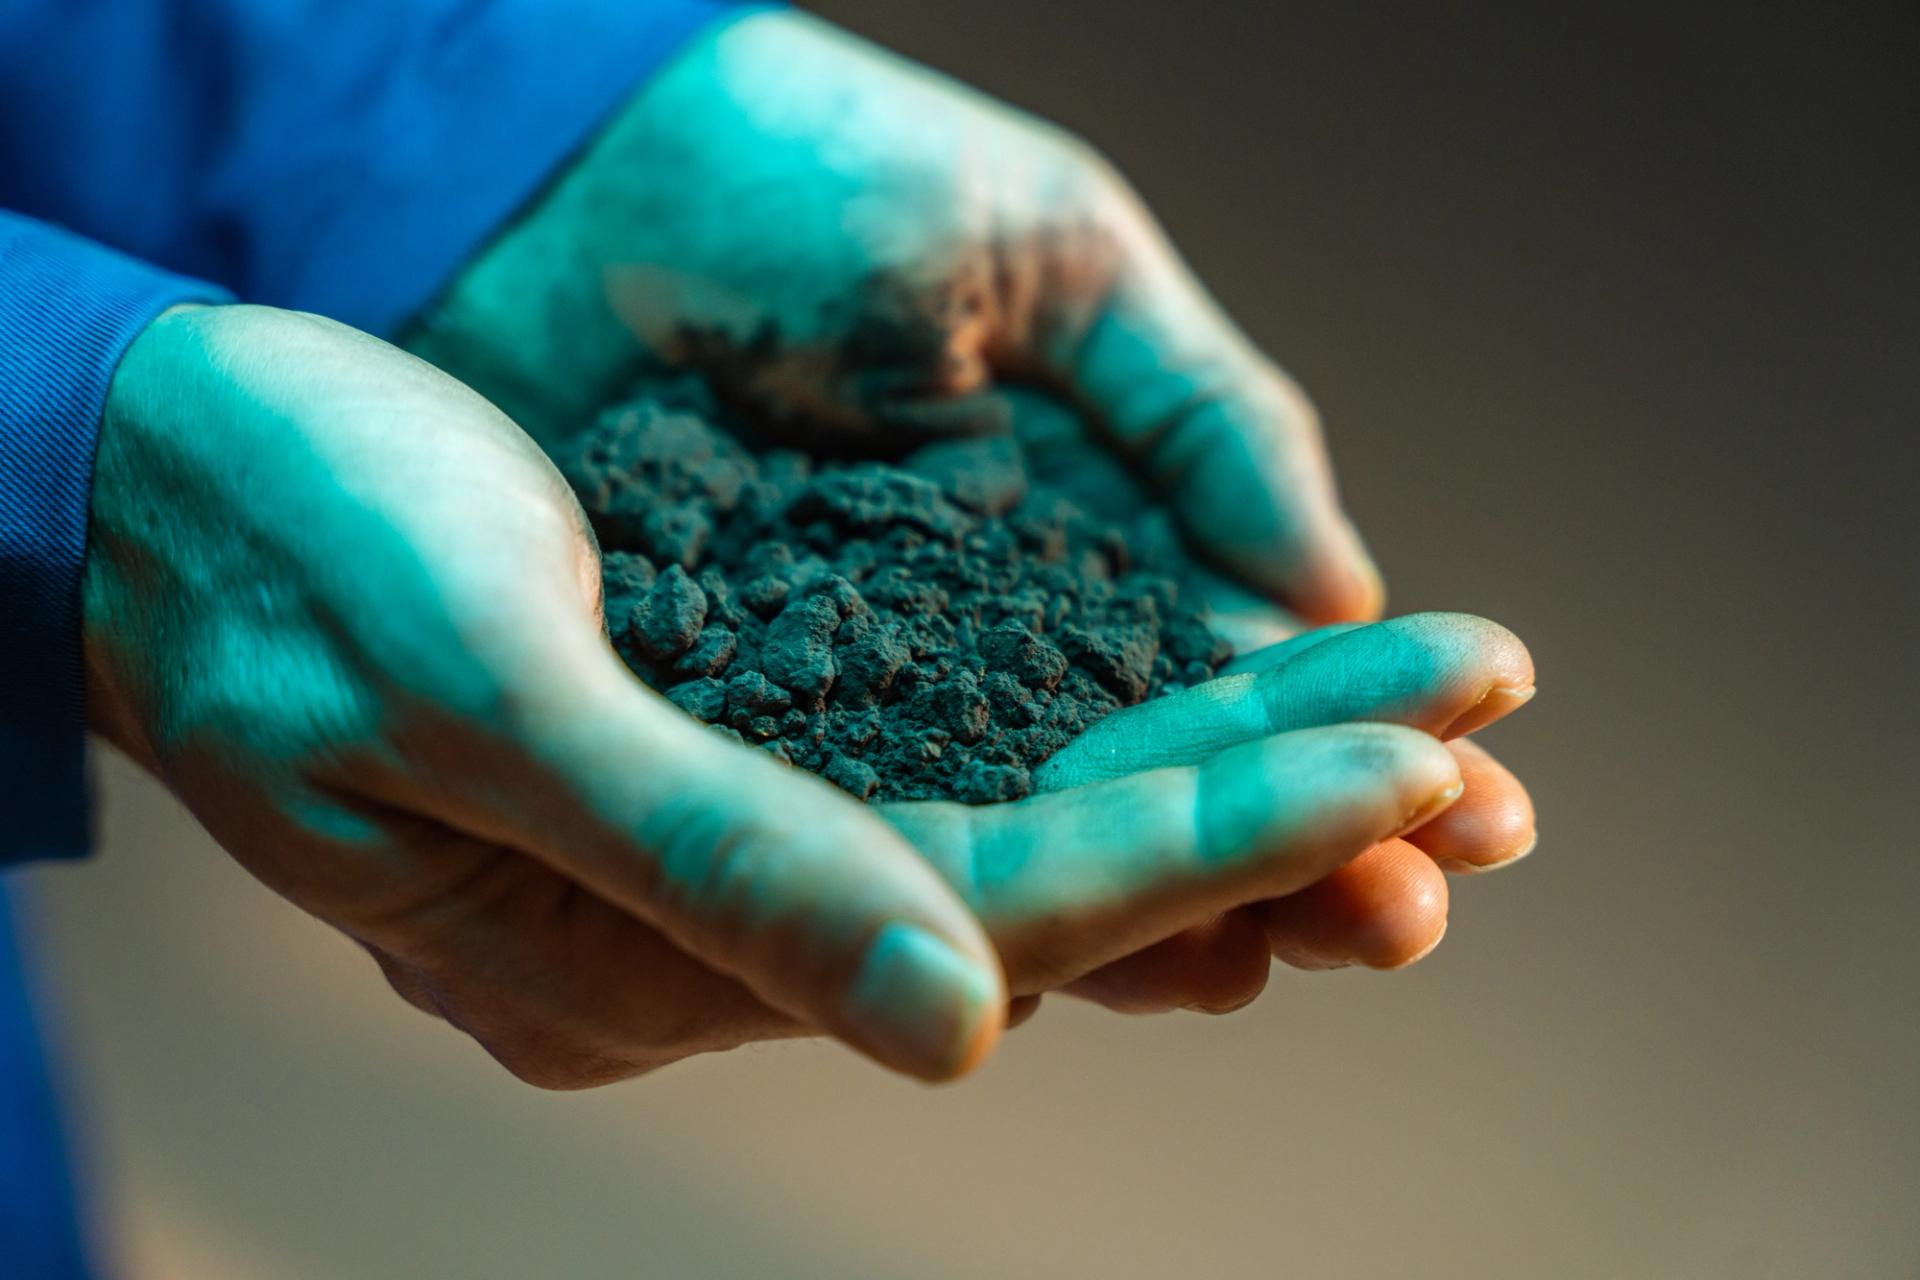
[0,875,92,1280]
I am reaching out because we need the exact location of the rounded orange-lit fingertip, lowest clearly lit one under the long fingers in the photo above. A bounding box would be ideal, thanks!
[1258,841,1448,969]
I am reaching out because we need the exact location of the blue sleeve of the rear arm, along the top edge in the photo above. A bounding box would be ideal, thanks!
[0,0,760,334]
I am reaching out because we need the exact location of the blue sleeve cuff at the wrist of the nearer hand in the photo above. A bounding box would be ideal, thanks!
[0,211,232,864]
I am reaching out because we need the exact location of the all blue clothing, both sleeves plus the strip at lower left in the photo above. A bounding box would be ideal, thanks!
[0,0,752,1258]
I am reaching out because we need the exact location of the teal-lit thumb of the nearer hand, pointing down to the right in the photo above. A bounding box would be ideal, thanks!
[449,649,1006,1080]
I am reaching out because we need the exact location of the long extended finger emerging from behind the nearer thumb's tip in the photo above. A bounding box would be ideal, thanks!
[883,725,1459,992]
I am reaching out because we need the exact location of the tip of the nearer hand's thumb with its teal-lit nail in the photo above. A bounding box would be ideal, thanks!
[845,921,1006,1080]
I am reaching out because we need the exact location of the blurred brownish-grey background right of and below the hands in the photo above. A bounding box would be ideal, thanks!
[18,0,1920,1280]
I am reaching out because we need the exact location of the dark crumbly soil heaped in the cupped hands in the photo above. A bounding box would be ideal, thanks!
[561,378,1229,804]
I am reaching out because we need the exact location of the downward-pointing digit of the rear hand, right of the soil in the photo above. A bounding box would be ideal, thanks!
[1043,184,1384,622]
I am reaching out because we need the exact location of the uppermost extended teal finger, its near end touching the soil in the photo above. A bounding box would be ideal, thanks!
[1035,614,1534,791]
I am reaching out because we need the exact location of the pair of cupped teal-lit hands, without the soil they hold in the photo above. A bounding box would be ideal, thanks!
[84,13,1534,1088]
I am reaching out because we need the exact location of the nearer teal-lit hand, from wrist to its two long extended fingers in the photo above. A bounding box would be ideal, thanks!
[84,307,1524,1088]
